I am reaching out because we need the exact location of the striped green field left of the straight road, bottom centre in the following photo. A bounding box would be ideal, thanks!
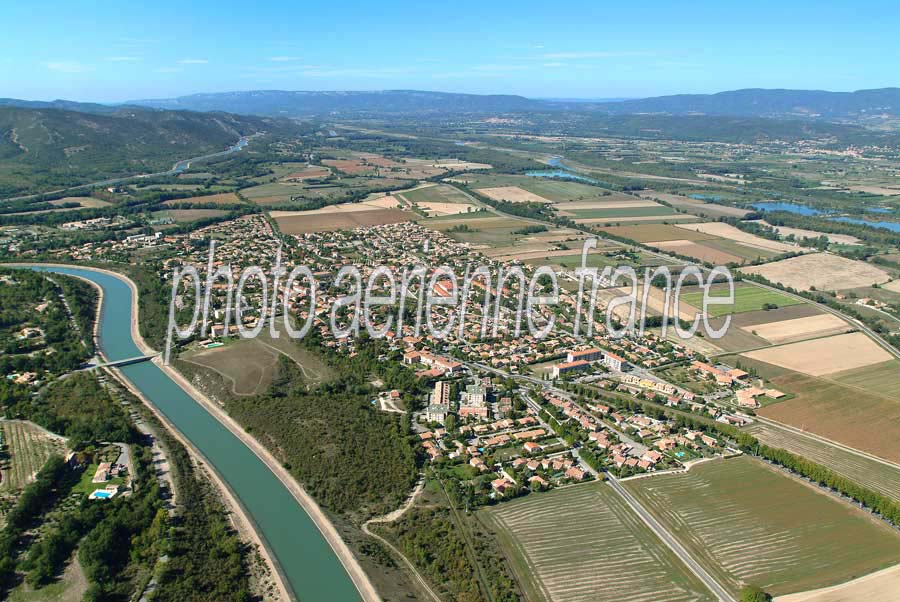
[479,483,714,602]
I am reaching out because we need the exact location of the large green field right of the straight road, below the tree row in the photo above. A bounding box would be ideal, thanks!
[624,457,900,594]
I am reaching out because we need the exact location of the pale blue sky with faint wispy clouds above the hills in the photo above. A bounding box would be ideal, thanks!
[0,0,900,102]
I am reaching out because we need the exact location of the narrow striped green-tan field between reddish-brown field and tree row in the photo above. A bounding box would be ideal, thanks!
[743,422,900,502]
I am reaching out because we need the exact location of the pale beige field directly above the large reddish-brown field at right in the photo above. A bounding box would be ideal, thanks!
[744,332,893,376]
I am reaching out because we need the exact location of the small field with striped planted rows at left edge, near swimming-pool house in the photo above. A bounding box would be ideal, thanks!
[0,420,66,496]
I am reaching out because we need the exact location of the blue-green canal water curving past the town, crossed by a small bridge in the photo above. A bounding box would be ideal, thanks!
[26,266,360,602]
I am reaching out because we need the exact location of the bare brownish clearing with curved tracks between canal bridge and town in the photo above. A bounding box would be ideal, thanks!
[181,330,331,396]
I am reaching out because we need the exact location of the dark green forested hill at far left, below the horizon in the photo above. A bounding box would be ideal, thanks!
[0,106,290,198]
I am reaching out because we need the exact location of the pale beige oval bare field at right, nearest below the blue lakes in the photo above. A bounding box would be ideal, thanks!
[741,253,890,291]
